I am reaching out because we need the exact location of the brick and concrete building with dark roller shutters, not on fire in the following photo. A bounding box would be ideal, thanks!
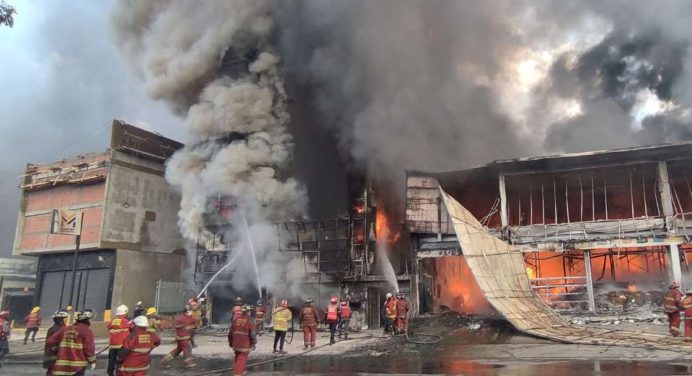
[14,120,185,318]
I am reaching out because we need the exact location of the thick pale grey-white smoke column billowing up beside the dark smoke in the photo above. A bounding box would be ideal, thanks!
[113,0,307,292]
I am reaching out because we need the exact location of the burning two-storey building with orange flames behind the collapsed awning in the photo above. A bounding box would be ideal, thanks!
[406,142,692,313]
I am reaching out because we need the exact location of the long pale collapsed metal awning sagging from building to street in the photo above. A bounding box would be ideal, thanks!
[440,189,692,352]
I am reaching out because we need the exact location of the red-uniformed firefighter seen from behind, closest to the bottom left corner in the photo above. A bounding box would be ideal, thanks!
[46,309,96,376]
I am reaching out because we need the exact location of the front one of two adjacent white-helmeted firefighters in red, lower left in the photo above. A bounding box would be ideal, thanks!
[118,316,161,376]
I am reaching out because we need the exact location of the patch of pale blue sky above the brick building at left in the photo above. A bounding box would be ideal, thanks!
[0,0,183,257]
